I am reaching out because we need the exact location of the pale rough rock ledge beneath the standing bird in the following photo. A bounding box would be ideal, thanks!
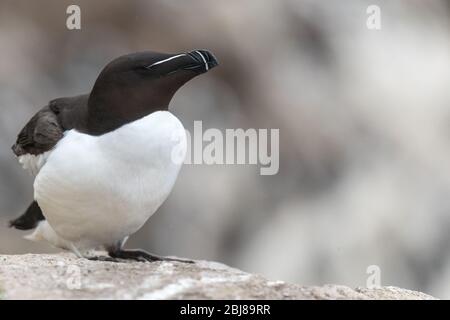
[0,253,434,299]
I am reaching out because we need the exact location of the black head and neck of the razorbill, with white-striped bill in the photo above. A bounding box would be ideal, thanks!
[87,50,218,134]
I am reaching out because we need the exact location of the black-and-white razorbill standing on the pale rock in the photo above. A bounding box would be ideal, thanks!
[10,50,218,263]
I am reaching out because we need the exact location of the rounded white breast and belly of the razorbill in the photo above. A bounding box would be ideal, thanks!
[34,111,186,247]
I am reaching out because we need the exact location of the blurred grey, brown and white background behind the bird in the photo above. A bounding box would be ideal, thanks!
[0,0,450,298]
